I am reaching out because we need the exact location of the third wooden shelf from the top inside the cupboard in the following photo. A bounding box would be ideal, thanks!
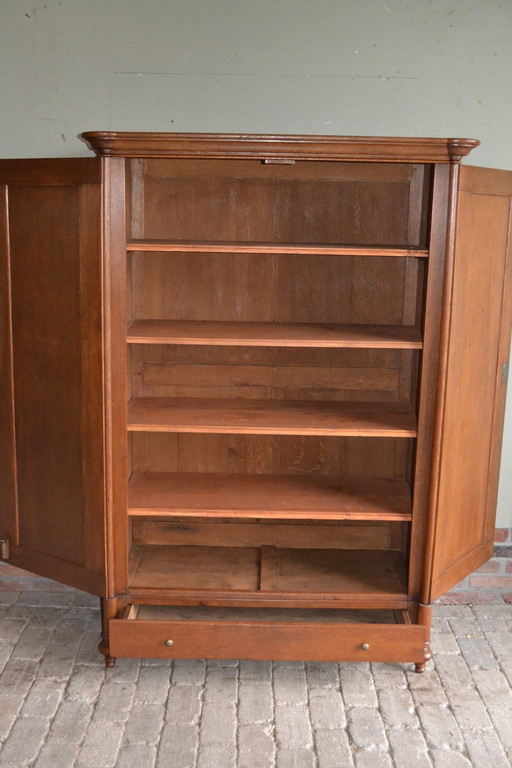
[127,397,416,437]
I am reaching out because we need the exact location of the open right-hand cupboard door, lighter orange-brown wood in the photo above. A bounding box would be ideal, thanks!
[430,166,512,600]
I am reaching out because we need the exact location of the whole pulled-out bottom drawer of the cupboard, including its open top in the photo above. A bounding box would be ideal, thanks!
[109,605,427,662]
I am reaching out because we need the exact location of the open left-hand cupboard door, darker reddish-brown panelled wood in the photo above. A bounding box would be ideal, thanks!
[0,158,106,595]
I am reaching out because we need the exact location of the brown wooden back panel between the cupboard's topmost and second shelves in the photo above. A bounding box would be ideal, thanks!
[128,253,423,325]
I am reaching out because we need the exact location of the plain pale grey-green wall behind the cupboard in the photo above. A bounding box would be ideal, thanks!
[0,0,512,527]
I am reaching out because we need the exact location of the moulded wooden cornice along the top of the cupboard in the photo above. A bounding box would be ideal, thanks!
[80,131,480,163]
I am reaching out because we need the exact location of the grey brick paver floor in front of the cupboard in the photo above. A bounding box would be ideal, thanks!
[0,590,512,768]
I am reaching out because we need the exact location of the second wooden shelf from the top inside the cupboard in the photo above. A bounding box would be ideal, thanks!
[127,320,422,349]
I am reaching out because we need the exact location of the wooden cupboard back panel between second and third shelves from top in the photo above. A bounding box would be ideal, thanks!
[127,344,417,401]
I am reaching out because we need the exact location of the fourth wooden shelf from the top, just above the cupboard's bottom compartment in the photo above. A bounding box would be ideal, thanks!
[128,472,411,521]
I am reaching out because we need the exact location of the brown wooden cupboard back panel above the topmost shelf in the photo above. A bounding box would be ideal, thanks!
[131,160,421,245]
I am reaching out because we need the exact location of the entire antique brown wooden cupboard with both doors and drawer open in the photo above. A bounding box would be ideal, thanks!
[0,132,512,671]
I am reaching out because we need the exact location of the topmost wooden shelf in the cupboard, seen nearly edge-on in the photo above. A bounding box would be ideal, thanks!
[126,240,428,258]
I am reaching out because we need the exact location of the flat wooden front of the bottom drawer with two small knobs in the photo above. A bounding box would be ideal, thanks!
[109,618,426,662]
